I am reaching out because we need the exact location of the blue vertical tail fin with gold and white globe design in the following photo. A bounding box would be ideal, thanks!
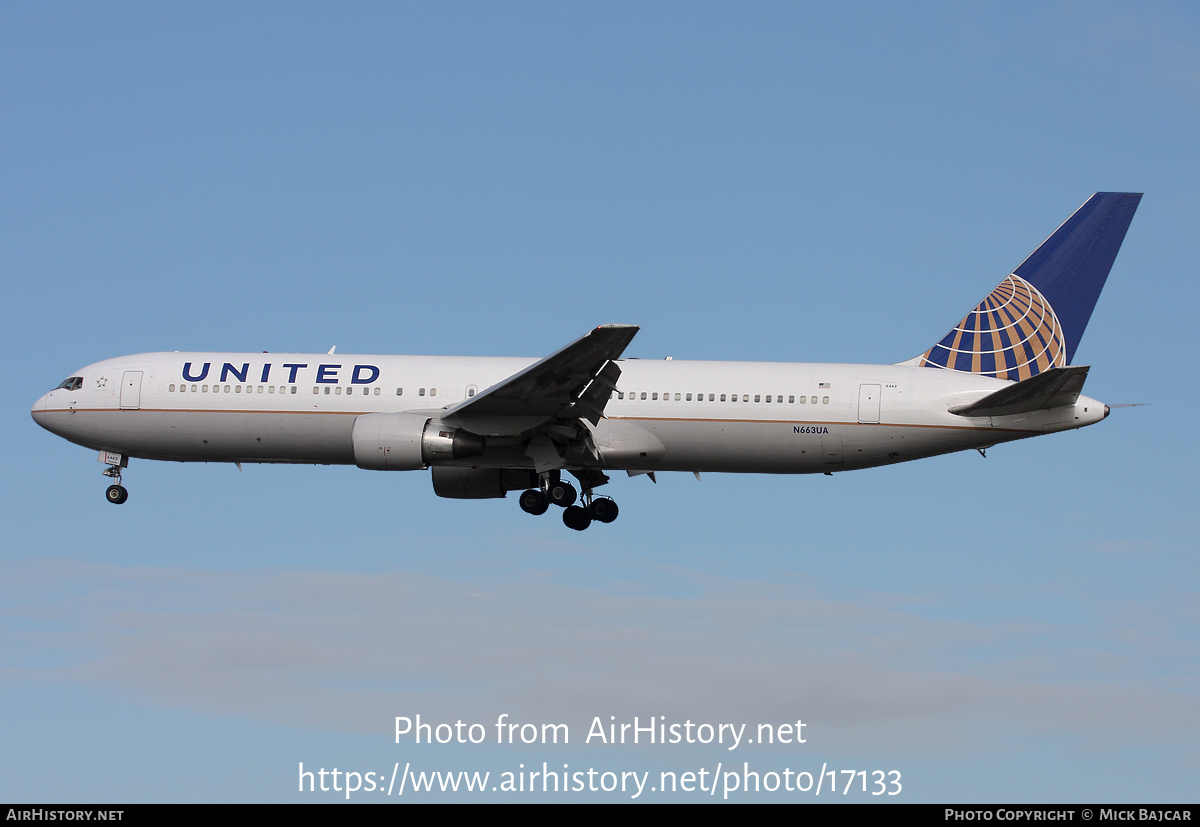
[906,192,1141,382]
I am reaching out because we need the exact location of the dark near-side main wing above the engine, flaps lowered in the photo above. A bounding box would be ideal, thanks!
[442,324,640,436]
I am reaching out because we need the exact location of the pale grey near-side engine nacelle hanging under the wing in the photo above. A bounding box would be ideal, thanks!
[352,413,487,470]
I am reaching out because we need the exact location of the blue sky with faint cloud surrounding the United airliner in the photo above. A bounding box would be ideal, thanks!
[0,2,1200,802]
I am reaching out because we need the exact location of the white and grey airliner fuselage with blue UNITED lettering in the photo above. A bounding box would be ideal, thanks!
[32,353,1106,474]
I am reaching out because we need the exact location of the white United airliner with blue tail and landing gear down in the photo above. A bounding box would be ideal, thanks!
[32,192,1141,531]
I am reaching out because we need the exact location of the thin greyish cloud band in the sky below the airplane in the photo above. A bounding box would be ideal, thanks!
[6,562,1200,754]
